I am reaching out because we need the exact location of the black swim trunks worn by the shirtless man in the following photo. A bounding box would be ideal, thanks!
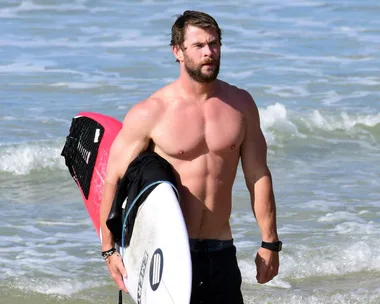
[190,239,243,304]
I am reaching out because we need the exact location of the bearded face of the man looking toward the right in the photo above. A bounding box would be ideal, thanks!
[183,26,220,83]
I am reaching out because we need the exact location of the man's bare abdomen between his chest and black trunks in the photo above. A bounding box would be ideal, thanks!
[169,151,238,240]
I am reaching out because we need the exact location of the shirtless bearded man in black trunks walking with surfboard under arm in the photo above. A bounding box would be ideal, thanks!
[100,11,281,304]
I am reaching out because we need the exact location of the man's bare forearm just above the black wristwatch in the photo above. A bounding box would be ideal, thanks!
[250,172,278,242]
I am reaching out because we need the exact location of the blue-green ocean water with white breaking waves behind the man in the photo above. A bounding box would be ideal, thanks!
[0,0,380,304]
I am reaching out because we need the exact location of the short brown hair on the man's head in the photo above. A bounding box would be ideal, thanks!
[170,11,222,47]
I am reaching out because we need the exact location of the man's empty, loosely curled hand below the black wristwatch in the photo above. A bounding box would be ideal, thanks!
[255,248,280,284]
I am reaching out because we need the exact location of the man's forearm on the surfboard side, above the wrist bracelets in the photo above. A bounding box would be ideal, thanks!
[100,182,116,251]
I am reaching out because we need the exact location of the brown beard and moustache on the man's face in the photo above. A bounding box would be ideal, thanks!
[185,56,220,83]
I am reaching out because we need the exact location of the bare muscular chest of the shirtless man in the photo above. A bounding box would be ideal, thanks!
[154,102,244,158]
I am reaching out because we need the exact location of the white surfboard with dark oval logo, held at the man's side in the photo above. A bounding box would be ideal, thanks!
[121,183,192,304]
